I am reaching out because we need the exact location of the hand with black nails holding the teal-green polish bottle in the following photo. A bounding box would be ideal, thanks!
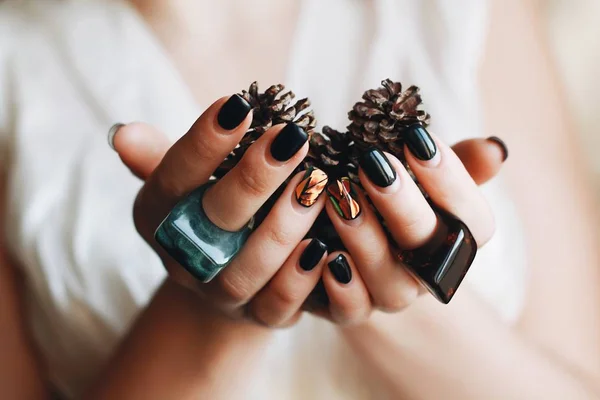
[111,95,326,326]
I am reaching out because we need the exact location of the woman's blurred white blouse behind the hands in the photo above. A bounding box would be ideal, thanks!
[0,0,525,399]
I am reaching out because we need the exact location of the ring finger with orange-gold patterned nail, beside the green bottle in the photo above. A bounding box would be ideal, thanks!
[207,170,325,308]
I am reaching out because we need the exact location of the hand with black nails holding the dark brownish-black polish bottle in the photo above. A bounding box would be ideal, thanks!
[314,128,506,324]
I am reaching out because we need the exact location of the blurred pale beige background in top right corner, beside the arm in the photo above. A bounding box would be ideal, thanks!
[545,0,600,195]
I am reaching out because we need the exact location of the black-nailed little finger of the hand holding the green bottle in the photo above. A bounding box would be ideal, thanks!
[249,239,327,327]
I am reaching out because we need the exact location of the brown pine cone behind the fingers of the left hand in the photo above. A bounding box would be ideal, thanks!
[214,82,317,178]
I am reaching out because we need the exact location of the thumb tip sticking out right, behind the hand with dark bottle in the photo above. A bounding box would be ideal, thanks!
[452,137,508,185]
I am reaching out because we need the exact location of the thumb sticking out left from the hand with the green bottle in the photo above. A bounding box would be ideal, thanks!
[108,122,171,181]
